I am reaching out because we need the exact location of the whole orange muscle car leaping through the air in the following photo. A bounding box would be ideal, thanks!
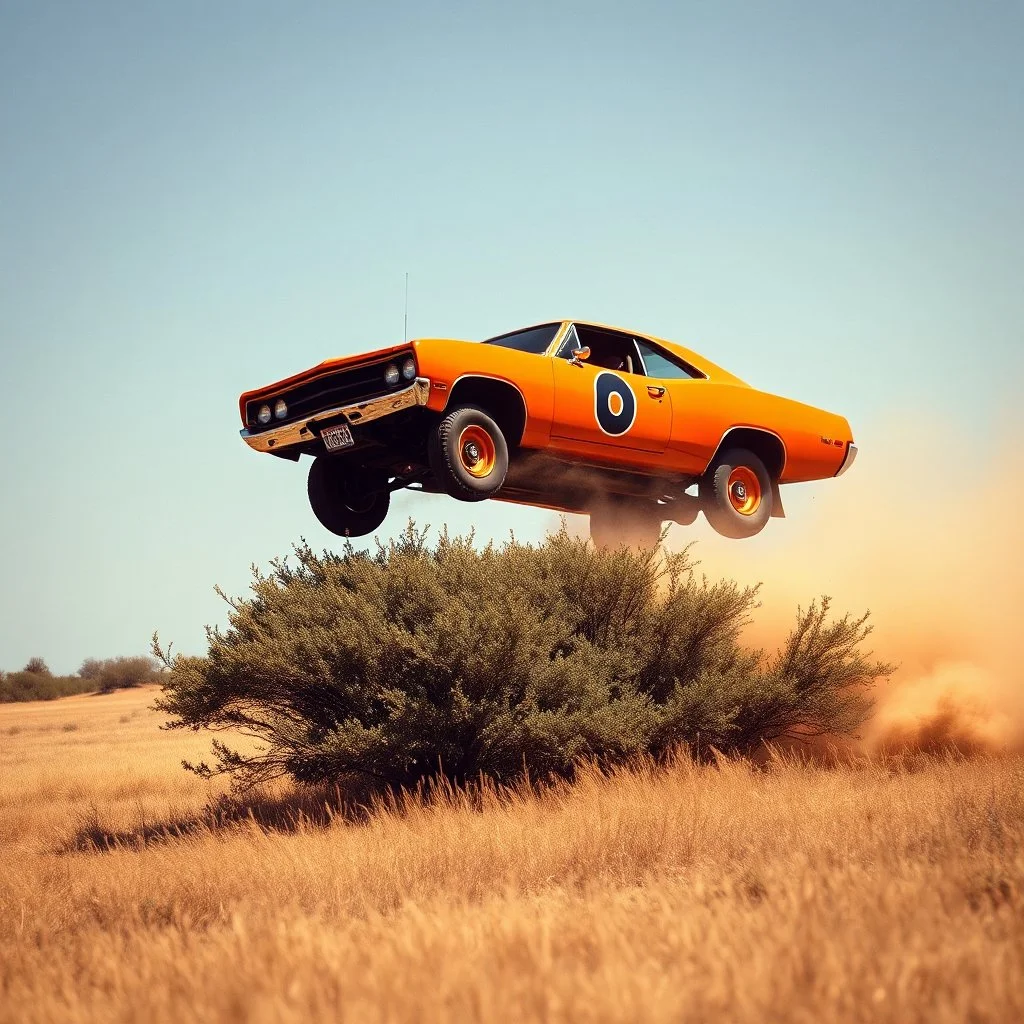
[239,321,857,544]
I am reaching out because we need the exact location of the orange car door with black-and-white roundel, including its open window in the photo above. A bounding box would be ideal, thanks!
[551,325,672,462]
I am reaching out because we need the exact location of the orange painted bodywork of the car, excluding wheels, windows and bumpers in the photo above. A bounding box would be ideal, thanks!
[239,321,853,483]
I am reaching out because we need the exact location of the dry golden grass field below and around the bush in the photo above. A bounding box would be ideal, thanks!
[0,690,1024,1024]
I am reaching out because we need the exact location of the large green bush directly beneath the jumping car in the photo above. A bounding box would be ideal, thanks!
[154,525,889,785]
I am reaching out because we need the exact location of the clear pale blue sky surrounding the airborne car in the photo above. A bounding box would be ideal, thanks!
[0,0,1024,671]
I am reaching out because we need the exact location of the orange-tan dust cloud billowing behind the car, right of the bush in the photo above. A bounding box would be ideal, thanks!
[561,419,1024,754]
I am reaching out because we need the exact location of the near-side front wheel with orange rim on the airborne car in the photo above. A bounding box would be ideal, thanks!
[427,406,509,502]
